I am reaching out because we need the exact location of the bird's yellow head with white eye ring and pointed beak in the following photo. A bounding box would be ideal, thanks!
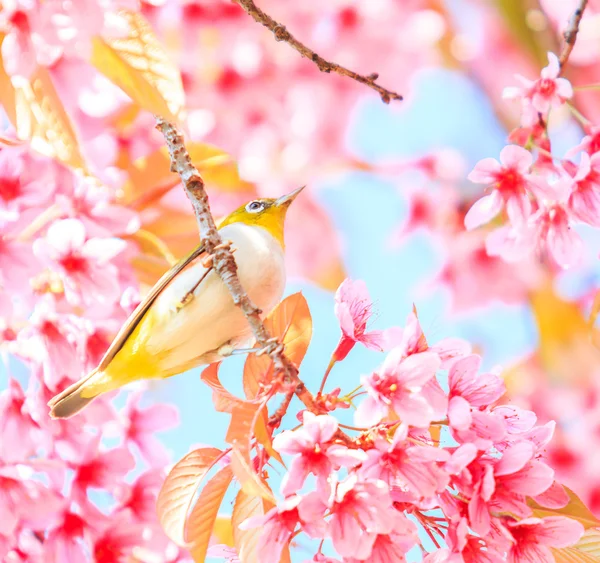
[219,186,305,246]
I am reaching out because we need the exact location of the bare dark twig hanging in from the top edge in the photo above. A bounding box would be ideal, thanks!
[234,0,402,104]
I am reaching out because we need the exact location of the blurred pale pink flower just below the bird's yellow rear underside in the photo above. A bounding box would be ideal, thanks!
[123,393,179,467]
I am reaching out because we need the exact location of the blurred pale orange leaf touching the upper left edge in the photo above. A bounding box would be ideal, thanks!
[0,34,85,170]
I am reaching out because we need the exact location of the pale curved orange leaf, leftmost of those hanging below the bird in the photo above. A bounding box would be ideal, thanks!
[156,448,223,546]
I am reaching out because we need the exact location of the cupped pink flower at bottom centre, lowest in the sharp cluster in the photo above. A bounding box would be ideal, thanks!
[329,474,396,560]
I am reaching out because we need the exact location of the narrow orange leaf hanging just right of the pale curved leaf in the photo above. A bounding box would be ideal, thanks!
[185,466,233,563]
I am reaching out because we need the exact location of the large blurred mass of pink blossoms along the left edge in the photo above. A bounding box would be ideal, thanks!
[0,147,183,563]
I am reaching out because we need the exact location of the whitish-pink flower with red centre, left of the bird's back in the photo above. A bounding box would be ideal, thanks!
[34,219,126,305]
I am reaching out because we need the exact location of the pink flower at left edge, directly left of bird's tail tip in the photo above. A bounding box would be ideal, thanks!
[0,378,48,463]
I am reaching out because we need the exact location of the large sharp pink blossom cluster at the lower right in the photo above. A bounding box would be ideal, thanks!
[213,280,584,563]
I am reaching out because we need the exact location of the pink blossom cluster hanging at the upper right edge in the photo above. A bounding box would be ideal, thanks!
[465,53,600,268]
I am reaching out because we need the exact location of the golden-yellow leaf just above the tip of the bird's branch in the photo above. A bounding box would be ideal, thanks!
[90,10,185,121]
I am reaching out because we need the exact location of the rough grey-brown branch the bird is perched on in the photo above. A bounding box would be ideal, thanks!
[156,117,352,444]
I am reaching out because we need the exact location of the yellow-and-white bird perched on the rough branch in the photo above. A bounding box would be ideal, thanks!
[48,186,304,419]
